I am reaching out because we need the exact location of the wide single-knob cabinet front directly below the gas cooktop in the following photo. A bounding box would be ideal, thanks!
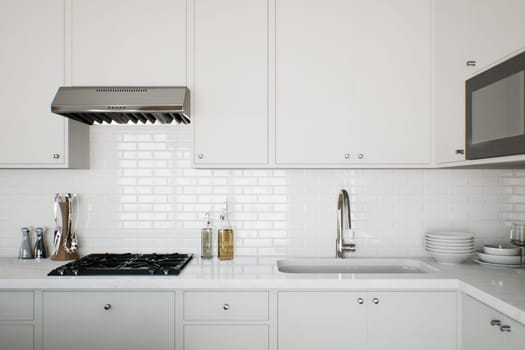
[43,292,175,350]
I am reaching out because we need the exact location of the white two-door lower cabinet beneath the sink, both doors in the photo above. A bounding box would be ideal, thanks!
[278,291,457,350]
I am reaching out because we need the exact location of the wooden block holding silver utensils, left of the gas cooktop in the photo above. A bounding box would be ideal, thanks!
[51,193,79,260]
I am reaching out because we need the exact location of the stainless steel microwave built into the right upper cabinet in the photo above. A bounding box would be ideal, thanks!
[465,52,525,159]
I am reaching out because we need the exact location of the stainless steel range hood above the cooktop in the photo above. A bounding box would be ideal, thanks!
[51,86,190,125]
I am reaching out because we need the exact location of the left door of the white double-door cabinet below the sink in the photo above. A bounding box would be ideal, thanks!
[278,292,367,350]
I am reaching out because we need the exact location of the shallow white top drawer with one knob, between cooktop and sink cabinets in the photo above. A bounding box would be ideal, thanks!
[184,292,268,321]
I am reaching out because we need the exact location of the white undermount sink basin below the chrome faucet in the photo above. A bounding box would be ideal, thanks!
[277,258,438,274]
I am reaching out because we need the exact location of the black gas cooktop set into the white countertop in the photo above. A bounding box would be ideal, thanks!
[47,253,193,276]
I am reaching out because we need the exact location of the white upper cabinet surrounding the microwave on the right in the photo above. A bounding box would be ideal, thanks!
[432,0,525,164]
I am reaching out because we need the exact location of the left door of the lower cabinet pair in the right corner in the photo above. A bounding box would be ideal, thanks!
[461,296,503,350]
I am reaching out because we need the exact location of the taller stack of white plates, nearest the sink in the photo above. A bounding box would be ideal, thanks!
[425,232,474,264]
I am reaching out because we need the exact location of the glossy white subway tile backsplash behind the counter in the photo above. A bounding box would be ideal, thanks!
[0,125,525,263]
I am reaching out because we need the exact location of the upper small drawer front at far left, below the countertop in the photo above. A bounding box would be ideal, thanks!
[0,292,33,321]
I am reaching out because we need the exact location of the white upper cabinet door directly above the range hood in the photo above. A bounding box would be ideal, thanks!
[71,0,186,86]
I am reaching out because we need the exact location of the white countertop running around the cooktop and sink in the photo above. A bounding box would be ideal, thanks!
[0,258,525,324]
